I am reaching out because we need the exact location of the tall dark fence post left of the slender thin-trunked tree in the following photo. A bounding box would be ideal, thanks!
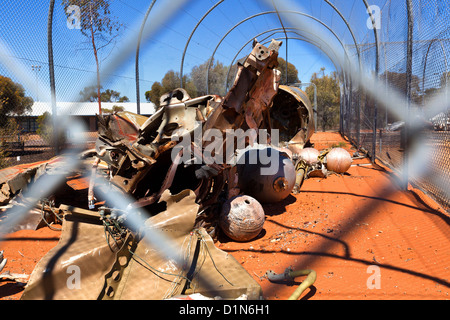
[47,0,59,154]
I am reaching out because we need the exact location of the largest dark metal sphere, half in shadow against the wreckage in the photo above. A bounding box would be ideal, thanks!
[237,147,295,203]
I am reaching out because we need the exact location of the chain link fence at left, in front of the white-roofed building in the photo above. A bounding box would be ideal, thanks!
[0,1,154,168]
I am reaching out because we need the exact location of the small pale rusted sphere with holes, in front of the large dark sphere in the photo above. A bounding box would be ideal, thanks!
[219,195,265,242]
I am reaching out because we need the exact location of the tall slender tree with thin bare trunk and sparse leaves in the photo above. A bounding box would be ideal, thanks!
[62,0,123,114]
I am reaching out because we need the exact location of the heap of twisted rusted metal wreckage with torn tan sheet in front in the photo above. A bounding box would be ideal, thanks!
[2,40,320,299]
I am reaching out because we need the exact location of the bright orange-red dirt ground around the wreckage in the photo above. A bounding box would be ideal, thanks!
[0,133,450,300]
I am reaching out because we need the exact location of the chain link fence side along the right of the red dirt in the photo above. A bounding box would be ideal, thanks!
[342,0,450,211]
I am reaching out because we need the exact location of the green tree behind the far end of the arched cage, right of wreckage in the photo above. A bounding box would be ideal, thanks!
[306,68,340,131]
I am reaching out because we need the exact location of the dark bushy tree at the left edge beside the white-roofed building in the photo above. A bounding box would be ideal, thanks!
[0,76,34,127]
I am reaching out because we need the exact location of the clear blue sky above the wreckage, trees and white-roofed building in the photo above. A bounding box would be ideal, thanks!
[0,0,442,107]
